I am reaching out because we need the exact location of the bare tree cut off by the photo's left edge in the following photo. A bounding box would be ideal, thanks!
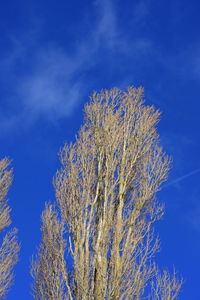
[0,158,19,298]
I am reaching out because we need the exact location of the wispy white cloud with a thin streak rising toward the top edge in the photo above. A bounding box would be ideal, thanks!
[18,1,118,120]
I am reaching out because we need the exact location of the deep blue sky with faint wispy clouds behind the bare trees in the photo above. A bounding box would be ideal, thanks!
[0,0,200,300]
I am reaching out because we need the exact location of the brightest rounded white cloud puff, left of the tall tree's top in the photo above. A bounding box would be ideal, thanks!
[18,49,82,120]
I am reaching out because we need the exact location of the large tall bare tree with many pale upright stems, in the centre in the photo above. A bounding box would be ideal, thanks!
[33,87,181,300]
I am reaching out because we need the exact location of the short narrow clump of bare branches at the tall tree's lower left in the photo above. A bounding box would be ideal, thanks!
[31,204,70,300]
